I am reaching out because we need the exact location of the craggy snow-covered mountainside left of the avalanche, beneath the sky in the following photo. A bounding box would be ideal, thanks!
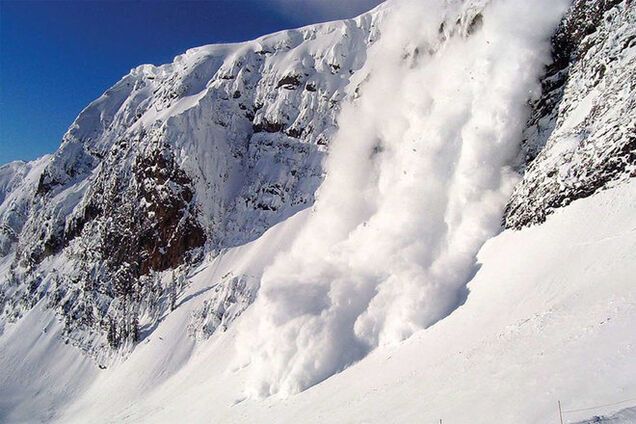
[0,10,382,362]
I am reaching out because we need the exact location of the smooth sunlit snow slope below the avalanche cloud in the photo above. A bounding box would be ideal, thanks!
[1,177,636,423]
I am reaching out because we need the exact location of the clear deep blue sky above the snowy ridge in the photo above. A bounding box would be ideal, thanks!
[0,0,381,164]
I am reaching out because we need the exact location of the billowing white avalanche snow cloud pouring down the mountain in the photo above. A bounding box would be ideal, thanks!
[238,0,567,397]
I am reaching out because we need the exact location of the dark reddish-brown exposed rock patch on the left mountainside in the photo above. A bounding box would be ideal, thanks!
[69,136,206,277]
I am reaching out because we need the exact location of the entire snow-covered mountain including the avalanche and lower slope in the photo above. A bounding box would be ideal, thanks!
[0,0,636,423]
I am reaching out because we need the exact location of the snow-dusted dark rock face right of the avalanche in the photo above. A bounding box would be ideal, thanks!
[505,0,636,228]
